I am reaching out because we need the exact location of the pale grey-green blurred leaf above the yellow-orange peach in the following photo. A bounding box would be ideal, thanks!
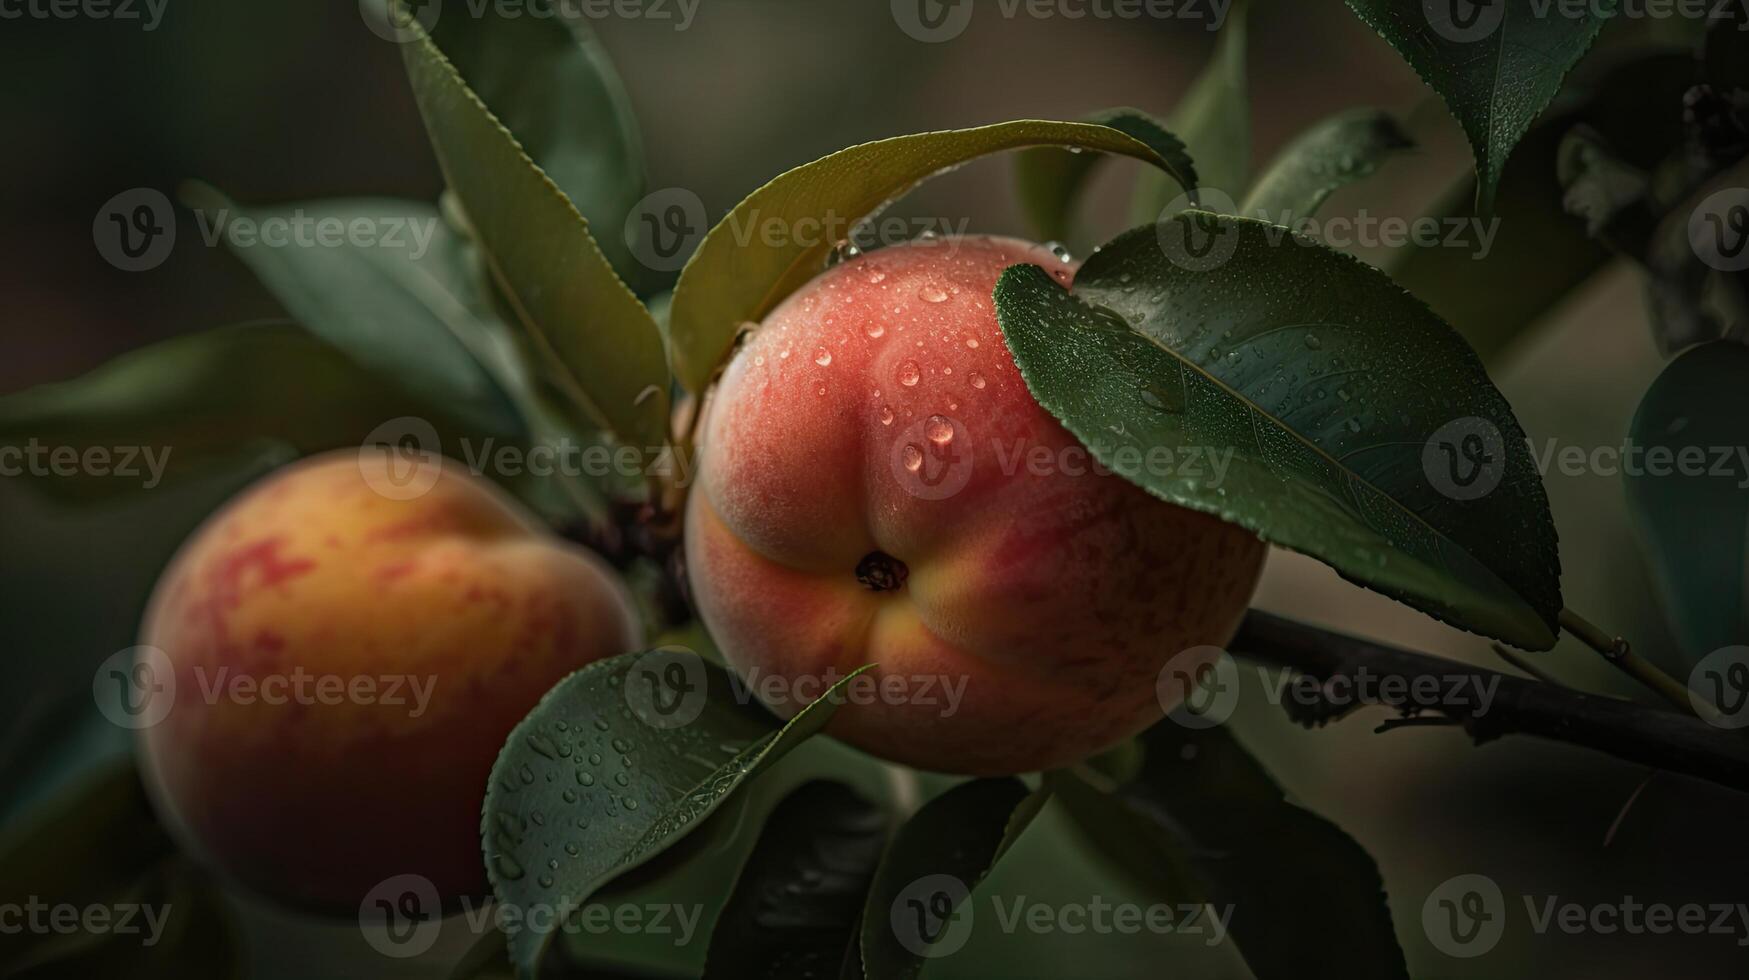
[184,186,528,434]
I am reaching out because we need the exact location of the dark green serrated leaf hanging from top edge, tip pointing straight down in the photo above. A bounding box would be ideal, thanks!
[1348,0,1614,215]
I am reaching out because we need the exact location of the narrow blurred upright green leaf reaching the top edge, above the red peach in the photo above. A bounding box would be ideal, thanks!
[1132,0,1251,222]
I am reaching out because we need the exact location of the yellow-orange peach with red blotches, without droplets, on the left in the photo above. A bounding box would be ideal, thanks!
[140,452,640,908]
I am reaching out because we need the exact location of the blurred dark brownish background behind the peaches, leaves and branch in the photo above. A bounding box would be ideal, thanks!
[0,0,1749,978]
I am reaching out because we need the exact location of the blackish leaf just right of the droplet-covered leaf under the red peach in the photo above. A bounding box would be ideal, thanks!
[705,782,887,980]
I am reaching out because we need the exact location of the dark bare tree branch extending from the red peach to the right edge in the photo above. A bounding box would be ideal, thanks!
[1230,609,1749,791]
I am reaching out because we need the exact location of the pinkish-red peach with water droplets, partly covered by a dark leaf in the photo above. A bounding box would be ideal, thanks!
[686,238,1265,774]
